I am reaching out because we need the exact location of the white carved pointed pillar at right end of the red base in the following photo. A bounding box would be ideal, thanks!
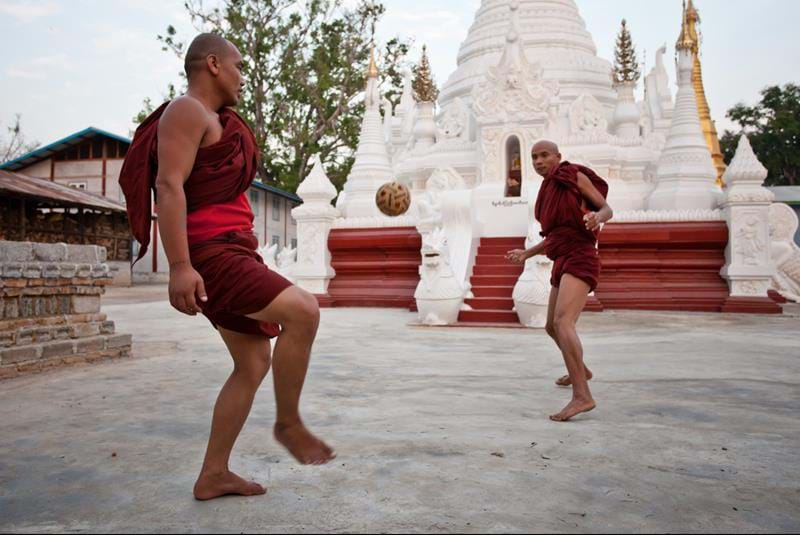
[721,135,774,297]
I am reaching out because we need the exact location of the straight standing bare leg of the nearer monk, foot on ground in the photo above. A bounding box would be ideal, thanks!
[194,328,270,500]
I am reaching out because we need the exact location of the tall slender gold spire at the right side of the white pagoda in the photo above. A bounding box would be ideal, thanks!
[675,0,727,187]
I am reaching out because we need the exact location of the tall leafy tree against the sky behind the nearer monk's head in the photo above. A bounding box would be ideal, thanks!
[135,0,409,191]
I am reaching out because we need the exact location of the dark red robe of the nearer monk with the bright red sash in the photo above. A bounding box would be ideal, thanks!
[119,103,291,336]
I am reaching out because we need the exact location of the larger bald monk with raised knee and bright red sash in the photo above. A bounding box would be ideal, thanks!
[120,34,335,500]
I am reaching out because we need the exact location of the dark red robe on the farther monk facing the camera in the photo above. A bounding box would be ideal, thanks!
[535,162,608,291]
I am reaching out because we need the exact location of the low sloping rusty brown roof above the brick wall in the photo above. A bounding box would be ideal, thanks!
[0,171,125,212]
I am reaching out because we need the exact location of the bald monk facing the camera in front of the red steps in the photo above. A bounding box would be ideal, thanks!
[507,141,613,422]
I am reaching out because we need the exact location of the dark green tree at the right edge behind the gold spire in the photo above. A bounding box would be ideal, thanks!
[720,84,800,186]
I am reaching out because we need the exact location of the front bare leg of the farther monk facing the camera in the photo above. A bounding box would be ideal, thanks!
[550,274,595,422]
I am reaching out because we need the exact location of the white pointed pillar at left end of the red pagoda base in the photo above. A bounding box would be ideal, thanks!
[292,156,339,295]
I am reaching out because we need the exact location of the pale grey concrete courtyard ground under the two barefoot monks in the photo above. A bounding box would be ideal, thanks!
[0,287,800,533]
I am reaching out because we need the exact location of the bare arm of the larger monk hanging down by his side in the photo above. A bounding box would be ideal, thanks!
[156,97,207,315]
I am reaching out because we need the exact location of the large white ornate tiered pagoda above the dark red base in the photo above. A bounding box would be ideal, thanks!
[300,0,800,318]
